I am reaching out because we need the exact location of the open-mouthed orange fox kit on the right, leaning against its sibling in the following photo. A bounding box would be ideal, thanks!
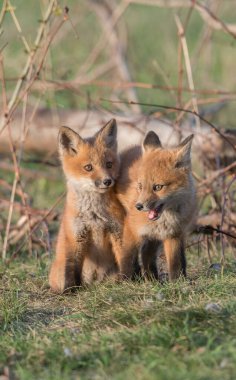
[116,131,196,280]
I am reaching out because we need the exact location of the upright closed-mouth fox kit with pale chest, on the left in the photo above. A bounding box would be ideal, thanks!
[49,119,123,292]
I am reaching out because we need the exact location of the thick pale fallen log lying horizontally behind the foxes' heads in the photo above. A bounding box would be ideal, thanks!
[0,107,236,161]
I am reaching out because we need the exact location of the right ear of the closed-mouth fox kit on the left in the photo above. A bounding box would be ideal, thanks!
[96,119,117,150]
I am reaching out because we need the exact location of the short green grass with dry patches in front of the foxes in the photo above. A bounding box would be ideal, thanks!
[0,256,236,380]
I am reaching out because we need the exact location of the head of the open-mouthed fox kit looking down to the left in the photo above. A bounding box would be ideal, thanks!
[135,131,193,220]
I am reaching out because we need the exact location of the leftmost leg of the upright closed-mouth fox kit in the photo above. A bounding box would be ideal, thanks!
[49,227,87,293]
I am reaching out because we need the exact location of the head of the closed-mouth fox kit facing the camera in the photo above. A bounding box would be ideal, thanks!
[58,119,119,193]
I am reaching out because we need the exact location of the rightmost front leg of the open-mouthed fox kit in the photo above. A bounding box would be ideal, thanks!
[163,237,186,280]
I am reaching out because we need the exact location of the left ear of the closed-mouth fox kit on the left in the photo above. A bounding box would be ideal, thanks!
[58,127,83,156]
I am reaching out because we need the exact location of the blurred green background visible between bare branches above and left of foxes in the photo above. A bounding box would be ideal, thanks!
[0,0,236,218]
